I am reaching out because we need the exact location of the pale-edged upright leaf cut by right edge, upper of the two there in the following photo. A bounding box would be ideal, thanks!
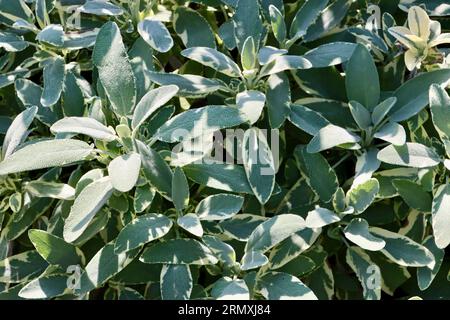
[430,84,450,139]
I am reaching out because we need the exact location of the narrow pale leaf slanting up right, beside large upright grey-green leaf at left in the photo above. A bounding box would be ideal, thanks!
[131,85,178,131]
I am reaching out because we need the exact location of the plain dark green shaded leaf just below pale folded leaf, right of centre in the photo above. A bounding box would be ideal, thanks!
[294,146,339,202]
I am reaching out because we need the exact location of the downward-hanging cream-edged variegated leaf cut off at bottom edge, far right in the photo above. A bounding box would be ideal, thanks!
[346,247,381,300]
